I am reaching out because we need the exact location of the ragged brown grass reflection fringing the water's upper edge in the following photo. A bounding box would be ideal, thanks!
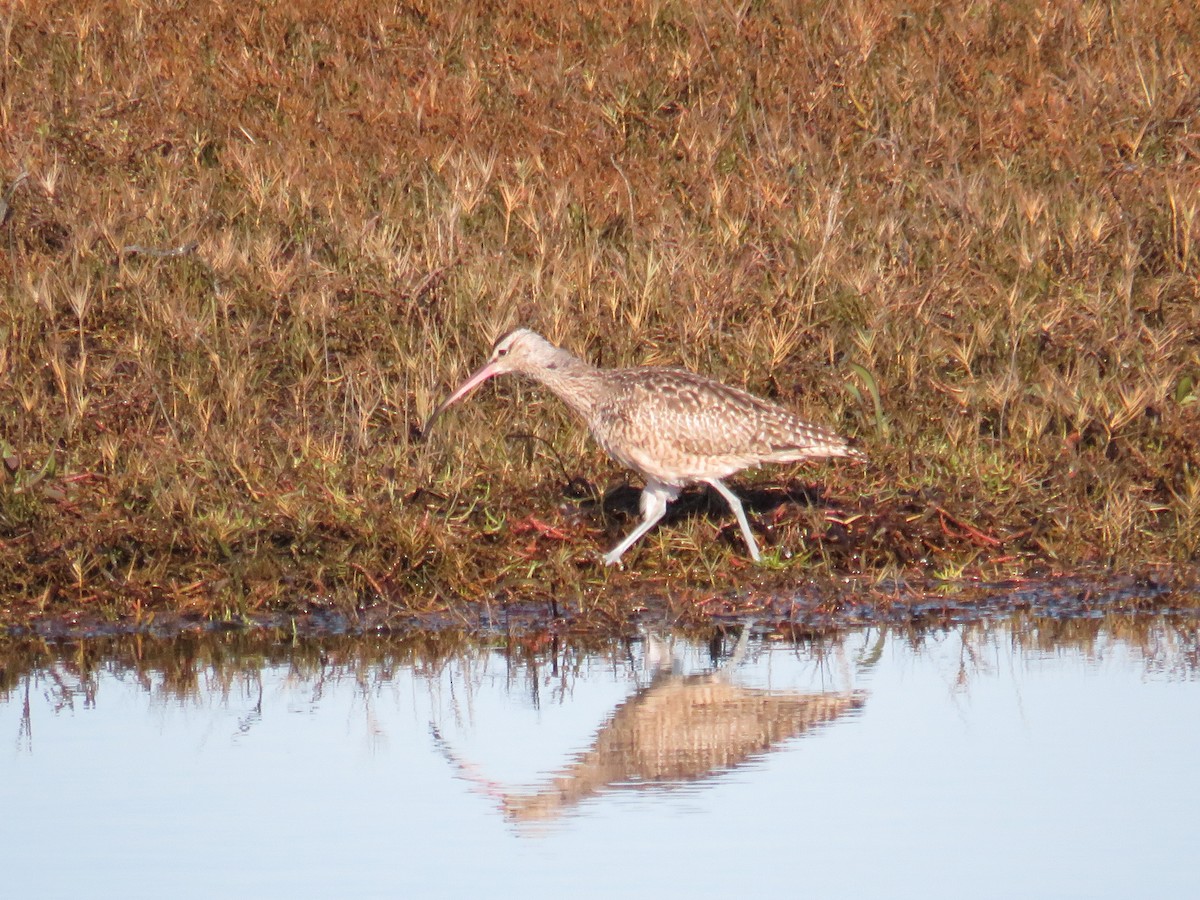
[0,613,1200,704]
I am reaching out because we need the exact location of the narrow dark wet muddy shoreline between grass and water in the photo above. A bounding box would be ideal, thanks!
[0,572,1200,642]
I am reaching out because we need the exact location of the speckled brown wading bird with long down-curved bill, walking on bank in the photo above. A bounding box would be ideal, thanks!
[425,328,863,565]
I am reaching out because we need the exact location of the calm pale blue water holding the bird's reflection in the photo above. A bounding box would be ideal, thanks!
[0,618,1200,898]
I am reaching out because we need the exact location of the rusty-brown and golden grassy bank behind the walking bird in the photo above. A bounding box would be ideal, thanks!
[0,0,1200,620]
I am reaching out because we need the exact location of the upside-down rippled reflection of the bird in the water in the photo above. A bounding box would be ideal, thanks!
[434,629,865,823]
